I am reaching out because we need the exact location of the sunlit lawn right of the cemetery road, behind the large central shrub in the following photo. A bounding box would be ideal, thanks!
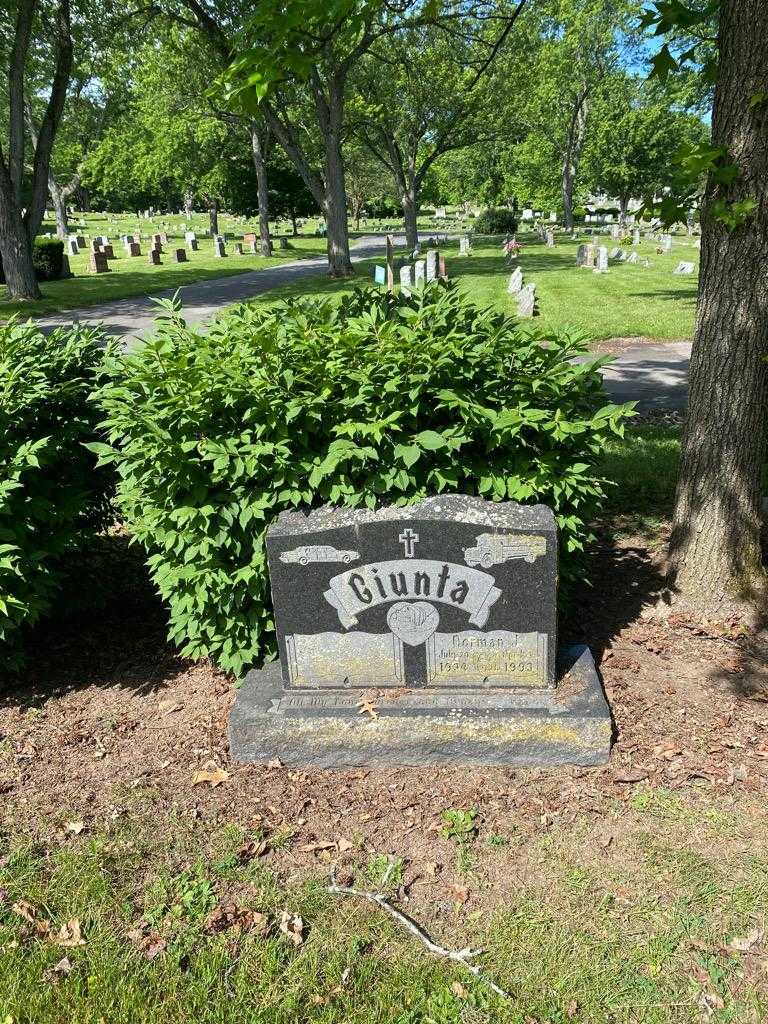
[247,232,698,340]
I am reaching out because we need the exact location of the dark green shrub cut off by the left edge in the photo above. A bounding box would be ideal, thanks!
[0,321,113,670]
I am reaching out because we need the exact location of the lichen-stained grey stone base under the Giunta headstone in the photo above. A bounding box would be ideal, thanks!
[229,645,612,768]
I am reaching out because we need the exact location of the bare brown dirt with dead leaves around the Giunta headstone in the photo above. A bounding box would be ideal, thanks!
[0,535,768,897]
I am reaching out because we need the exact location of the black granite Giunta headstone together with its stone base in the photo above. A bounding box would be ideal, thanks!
[229,495,611,767]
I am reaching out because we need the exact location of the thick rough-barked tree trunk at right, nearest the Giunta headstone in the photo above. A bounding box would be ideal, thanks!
[670,0,768,608]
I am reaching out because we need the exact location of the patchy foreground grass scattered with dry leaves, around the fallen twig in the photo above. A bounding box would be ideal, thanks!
[0,787,768,1024]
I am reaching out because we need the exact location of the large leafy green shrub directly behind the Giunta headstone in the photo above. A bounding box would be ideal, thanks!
[91,284,627,673]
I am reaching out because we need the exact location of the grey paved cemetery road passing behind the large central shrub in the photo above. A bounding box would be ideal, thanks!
[38,236,690,411]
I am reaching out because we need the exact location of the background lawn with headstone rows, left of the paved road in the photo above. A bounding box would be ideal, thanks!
[0,207,326,318]
